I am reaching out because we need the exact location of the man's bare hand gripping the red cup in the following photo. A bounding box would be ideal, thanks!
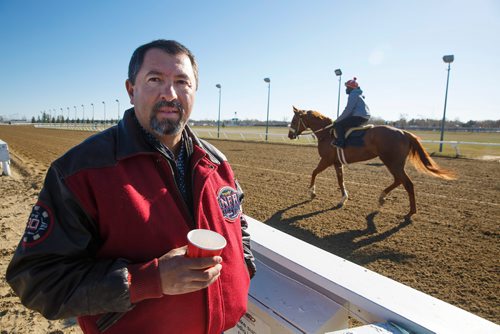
[158,246,222,295]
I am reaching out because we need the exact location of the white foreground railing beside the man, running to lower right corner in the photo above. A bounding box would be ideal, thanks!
[237,217,500,333]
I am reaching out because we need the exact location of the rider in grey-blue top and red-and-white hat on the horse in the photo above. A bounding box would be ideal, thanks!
[332,78,370,148]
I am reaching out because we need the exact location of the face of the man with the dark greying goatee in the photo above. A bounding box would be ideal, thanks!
[126,49,197,139]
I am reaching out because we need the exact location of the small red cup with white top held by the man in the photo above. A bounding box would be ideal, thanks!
[186,229,227,257]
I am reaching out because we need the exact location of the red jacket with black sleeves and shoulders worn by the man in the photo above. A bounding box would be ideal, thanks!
[6,108,255,334]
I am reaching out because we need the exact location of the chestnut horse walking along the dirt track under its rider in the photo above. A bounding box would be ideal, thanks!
[288,106,456,219]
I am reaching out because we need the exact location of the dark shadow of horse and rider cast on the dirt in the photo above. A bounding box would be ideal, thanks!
[264,200,413,265]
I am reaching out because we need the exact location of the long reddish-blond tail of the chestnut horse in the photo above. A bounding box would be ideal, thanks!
[403,130,456,180]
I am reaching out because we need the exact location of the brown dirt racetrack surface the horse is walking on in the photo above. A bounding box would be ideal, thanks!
[0,126,500,334]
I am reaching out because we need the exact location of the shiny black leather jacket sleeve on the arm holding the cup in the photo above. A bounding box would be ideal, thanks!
[6,165,132,319]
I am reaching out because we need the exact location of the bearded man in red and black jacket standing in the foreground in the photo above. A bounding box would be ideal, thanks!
[6,40,255,334]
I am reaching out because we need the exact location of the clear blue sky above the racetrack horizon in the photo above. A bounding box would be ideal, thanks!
[0,0,500,122]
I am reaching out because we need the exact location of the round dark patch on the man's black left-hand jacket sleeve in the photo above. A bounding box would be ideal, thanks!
[23,202,54,247]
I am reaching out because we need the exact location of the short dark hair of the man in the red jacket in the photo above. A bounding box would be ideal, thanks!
[128,39,198,88]
